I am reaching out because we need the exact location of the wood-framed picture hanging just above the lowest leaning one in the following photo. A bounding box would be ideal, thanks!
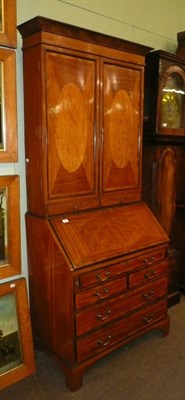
[0,175,21,279]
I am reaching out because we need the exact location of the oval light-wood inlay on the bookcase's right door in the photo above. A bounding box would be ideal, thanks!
[109,90,133,168]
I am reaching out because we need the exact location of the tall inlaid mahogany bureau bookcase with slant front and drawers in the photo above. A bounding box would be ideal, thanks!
[19,17,169,390]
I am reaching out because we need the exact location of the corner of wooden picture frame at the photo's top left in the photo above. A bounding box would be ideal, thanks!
[0,0,17,48]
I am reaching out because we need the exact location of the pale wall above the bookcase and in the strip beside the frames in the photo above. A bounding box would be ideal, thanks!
[0,0,185,286]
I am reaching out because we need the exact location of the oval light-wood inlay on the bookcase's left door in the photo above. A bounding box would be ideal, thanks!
[55,83,87,172]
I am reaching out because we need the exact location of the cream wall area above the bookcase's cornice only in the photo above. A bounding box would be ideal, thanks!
[17,0,185,52]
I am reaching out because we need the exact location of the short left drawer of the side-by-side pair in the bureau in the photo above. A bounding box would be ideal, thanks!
[75,276,127,309]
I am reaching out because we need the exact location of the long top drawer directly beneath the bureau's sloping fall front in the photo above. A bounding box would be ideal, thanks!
[79,248,166,288]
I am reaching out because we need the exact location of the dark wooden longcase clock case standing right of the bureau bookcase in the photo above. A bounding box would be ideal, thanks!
[142,50,185,307]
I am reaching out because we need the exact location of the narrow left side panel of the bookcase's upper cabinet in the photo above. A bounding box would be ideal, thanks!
[23,46,44,214]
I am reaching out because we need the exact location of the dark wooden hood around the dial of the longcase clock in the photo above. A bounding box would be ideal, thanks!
[144,50,185,142]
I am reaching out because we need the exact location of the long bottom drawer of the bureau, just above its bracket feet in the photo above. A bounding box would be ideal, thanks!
[77,300,167,362]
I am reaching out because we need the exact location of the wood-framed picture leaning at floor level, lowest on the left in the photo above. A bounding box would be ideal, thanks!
[0,278,35,390]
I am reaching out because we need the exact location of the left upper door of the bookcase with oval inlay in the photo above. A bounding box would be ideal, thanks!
[46,51,98,212]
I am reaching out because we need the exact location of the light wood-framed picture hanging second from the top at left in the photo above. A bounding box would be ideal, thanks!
[0,48,17,163]
